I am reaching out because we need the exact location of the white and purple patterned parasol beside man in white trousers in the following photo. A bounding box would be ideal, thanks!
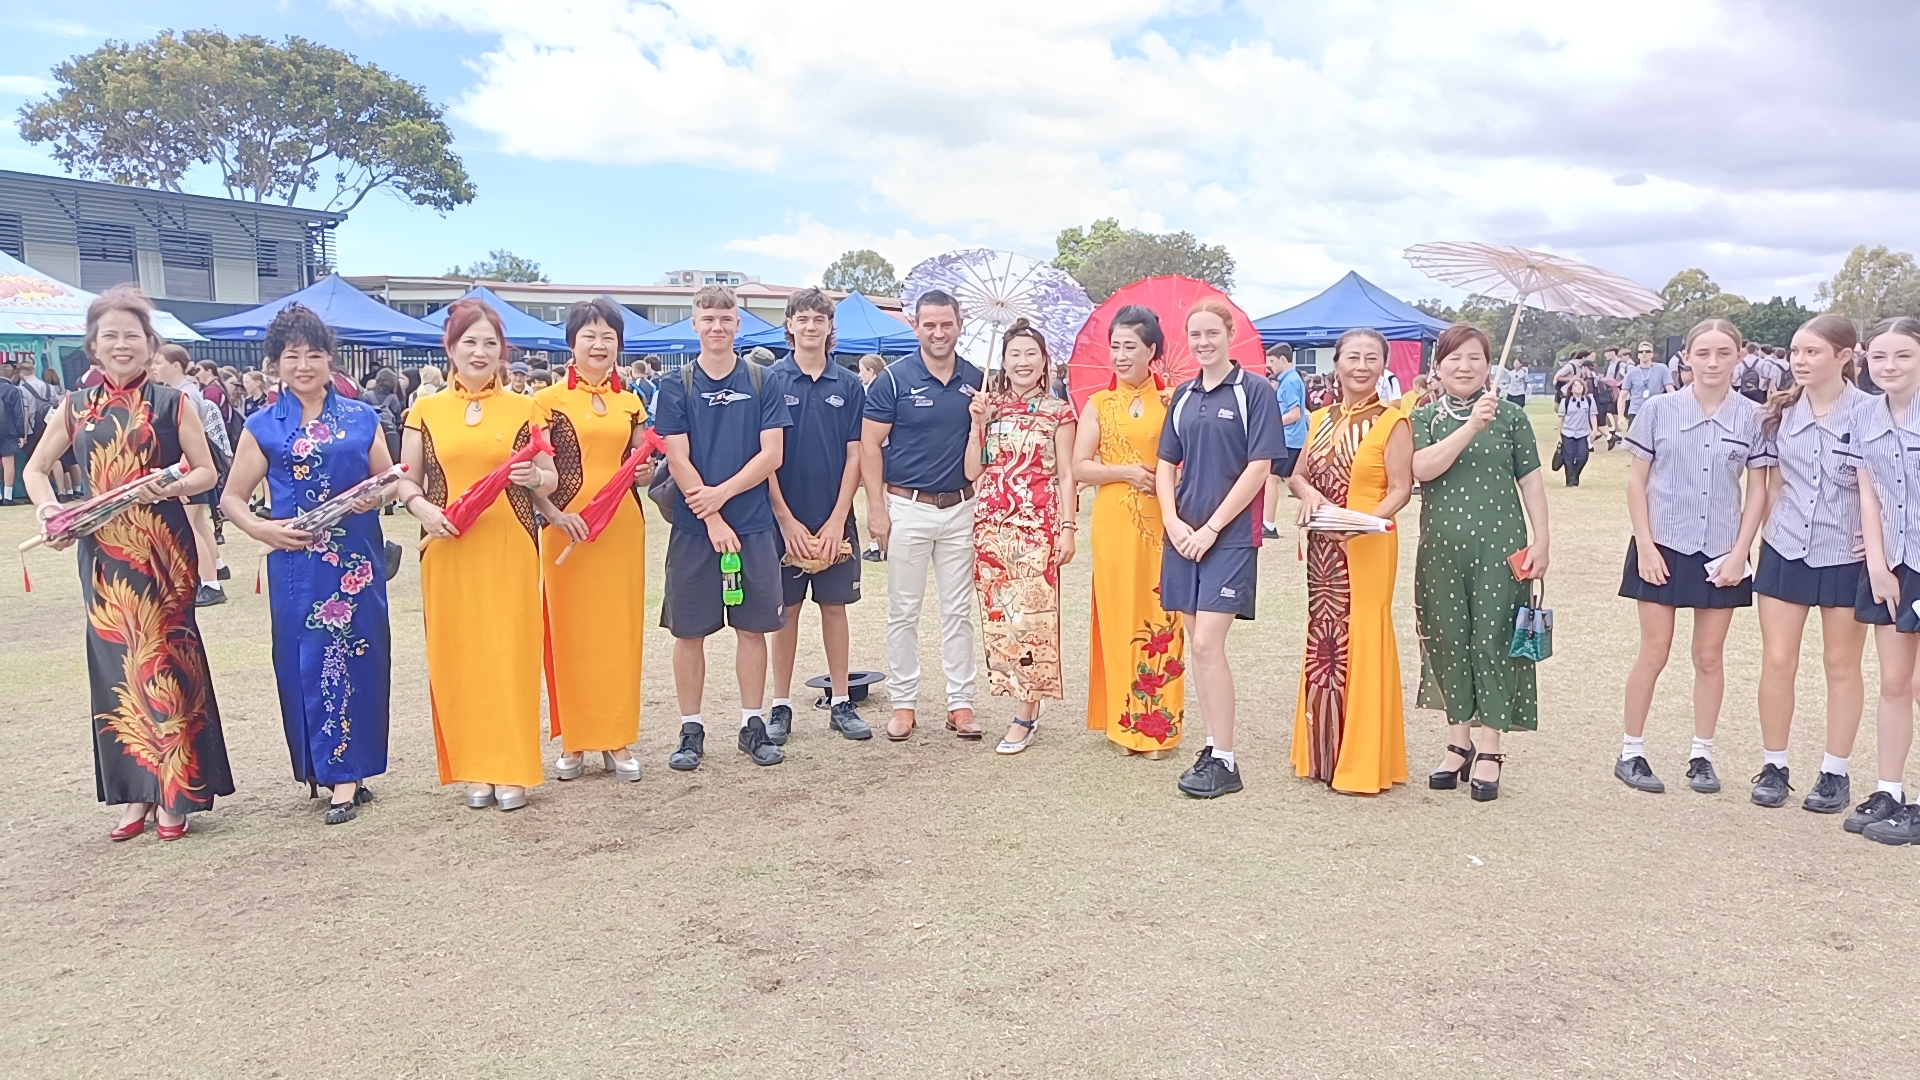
[900,248,1092,371]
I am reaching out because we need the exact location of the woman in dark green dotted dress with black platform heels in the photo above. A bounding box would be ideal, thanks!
[1413,323,1548,801]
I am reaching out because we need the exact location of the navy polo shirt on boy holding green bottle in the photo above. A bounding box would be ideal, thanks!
[653,359,793,536]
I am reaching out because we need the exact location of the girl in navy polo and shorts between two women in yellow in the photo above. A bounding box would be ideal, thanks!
[1158,300,1286,799]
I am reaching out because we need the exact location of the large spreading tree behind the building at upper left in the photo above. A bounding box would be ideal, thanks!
[19,31,474,211]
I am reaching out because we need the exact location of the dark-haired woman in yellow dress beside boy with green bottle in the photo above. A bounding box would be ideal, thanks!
[534,296,653,780]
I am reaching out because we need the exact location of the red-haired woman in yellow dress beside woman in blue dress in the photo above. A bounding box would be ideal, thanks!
[397,300,555,811]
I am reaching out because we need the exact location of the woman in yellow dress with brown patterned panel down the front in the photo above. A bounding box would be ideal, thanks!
[1288,331,1413,796]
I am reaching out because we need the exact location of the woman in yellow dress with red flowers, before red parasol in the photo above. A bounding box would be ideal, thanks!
[1073,306,1187,759]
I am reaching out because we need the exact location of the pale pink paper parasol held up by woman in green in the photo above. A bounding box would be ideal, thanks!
[1405,242,1667,367]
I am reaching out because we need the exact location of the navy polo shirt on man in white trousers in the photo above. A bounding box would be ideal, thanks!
[866,352,990,496]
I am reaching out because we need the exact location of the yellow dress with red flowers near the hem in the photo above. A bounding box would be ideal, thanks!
[1087,382,1187,751]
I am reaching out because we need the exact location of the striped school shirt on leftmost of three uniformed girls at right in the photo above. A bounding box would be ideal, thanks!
[1626,386,1772,557]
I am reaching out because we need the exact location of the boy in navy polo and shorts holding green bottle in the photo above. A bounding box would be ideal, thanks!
[653,284,793,773]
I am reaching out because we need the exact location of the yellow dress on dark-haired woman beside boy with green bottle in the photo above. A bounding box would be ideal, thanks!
[534,369,647,753]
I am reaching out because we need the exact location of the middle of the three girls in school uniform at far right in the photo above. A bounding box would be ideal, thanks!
[1753,315,1874,813]
